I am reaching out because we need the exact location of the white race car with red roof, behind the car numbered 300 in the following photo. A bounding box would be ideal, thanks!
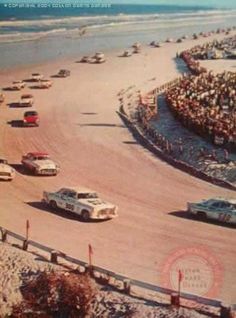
[21,152,60,176]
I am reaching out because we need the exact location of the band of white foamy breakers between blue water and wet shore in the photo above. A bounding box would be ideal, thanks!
[0,10,236,43]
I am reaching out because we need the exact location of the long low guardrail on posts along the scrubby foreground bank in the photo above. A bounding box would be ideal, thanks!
[0,227,233,318]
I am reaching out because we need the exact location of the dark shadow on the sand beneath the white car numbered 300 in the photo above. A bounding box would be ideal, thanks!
[25,201,107,223]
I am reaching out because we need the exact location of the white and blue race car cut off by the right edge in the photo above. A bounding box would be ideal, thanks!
[187,198,236,224]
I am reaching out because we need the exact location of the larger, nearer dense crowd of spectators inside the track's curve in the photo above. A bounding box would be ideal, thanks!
[166,71,236,148]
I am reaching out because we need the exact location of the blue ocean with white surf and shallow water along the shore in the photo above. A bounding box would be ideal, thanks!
[0,0,236,69]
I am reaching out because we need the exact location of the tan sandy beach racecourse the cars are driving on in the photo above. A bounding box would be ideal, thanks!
[0,30,236,310]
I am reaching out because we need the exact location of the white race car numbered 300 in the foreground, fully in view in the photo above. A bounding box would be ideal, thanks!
[42,188,117,221]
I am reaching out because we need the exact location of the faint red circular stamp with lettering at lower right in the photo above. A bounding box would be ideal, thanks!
[160,246,223,298]
